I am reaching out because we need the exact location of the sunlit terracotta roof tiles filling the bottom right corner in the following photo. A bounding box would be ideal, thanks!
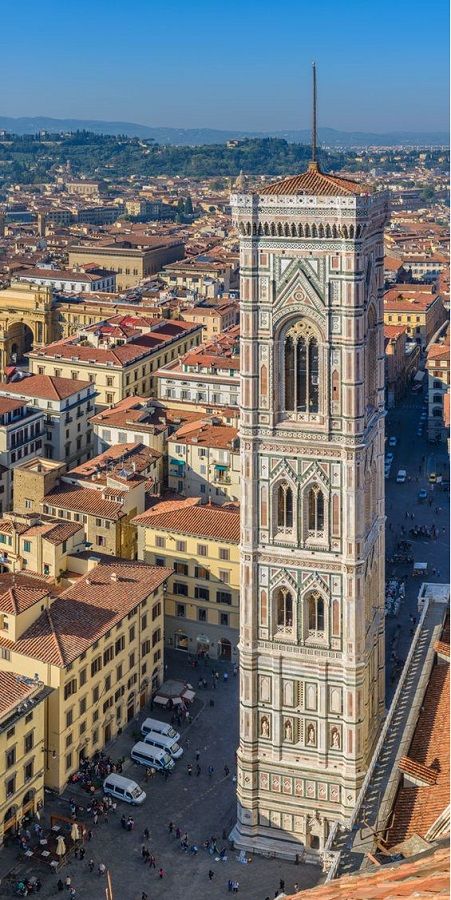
[287,847,450,900]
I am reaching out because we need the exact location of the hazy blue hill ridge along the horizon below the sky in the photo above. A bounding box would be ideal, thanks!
[0,116,449,147]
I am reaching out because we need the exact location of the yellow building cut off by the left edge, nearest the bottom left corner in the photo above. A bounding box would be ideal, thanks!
[0,668,51,846]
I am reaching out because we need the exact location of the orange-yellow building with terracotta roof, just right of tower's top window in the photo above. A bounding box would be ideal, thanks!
[384,284,446,347]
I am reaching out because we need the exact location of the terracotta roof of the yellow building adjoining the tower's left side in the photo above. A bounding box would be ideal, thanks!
[132,498,240,543]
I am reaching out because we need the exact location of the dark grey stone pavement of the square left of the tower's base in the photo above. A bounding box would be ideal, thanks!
[1,651,324,900]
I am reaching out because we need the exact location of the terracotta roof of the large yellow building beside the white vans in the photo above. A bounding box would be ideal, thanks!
[0,559,172,667]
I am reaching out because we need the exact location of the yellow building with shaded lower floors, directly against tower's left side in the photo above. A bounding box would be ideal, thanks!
[134,498,240,660]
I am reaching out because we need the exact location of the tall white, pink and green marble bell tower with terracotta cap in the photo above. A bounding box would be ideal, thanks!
[231,162,388,858]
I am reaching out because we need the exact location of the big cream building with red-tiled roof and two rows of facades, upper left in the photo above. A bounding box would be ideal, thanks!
[29,315,202,407]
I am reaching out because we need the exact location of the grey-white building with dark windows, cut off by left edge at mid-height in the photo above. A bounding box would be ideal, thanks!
[0,397,45,513]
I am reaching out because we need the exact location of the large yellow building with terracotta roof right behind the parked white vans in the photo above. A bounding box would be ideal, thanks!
[0,557,171,792]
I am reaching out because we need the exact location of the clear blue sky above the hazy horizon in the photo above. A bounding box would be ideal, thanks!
[0,0,448,131]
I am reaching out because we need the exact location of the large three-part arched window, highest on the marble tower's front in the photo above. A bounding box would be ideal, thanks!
[284,322,319,413]
